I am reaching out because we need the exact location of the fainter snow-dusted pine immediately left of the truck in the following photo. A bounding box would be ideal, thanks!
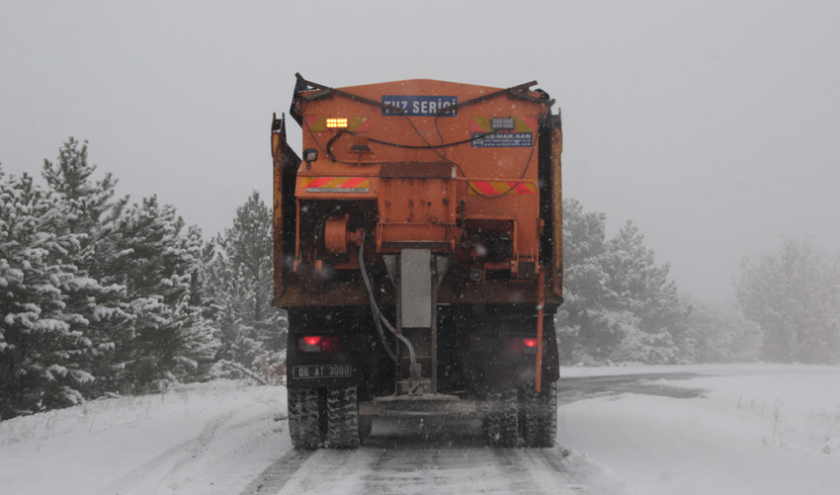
[207,191,287,380]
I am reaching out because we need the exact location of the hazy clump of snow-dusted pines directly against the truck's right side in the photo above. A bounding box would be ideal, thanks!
[557,199,692,362]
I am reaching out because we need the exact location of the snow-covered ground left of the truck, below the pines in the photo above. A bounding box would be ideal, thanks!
[0,381,290,495]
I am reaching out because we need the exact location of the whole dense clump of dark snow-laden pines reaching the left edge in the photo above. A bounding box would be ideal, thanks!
[0,138,219,418]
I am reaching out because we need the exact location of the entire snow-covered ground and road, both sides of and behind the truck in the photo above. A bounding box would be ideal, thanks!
[0,365,840,495]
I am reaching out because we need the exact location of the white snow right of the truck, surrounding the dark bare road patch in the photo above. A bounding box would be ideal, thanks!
[558,365,840,495]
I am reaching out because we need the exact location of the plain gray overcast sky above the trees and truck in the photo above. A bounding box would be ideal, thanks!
[0,0,840,300]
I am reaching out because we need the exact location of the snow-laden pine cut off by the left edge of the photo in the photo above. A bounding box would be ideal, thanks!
[0,170,95,419]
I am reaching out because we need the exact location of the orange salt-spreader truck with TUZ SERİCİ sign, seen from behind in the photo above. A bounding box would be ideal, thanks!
[271,74,563,449]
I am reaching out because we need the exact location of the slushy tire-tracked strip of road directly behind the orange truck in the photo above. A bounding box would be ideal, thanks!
[242,420,587,495]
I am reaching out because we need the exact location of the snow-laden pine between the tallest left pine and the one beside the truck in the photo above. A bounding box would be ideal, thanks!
[108,196,218,390]
